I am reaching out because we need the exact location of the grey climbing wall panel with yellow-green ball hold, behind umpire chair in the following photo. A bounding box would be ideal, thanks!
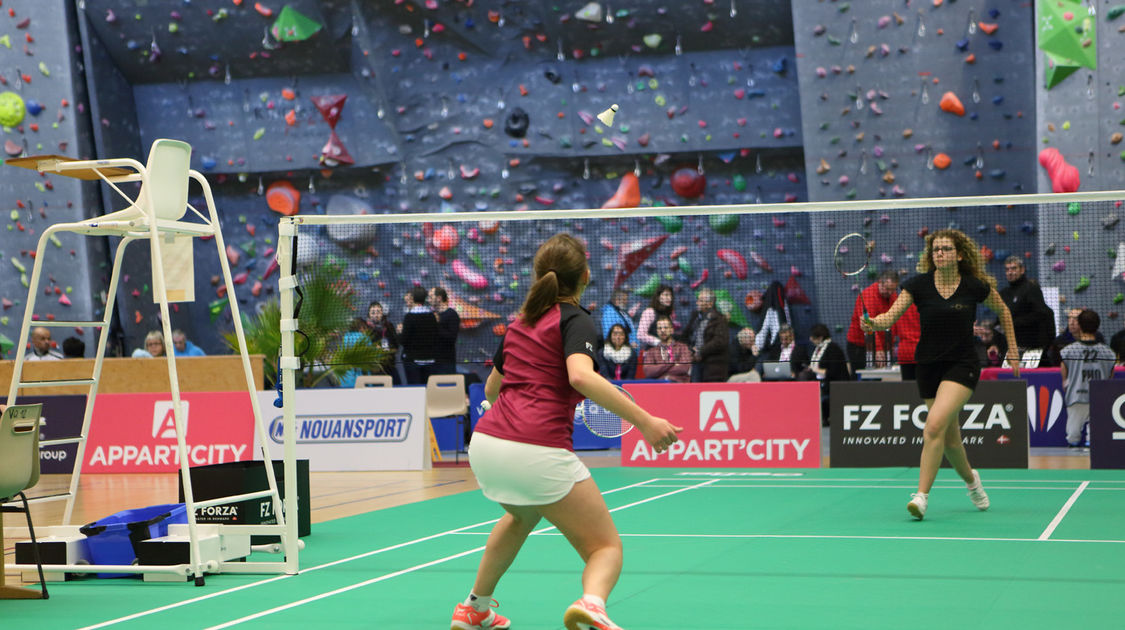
[0,0,106,359]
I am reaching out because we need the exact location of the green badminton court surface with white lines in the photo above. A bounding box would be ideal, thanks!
[0,468,1125,630]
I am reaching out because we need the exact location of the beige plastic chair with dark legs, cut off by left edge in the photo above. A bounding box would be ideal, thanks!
[0,404,47,600]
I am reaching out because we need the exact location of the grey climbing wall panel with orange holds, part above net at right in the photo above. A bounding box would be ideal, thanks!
[793,0,1035,200]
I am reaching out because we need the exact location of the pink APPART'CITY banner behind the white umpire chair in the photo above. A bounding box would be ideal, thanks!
[82,392,254,473]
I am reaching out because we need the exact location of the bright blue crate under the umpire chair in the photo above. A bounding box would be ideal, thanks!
[79,503,188,577]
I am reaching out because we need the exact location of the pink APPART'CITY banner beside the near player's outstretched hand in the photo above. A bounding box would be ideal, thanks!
[621,381,820,468]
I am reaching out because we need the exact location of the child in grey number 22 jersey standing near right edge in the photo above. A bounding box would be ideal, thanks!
[1059,308,1115,448]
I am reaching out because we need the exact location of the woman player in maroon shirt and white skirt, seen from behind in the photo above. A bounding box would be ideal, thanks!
[452,234,682,630]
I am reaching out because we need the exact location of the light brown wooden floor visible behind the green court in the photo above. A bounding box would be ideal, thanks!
[3,449,1090,583]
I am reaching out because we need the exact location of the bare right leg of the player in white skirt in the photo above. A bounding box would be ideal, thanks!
[539,478,622,600]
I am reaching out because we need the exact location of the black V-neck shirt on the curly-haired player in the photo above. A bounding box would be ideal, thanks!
[902,271,992,365]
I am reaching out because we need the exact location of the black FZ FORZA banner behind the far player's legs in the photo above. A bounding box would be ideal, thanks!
[829,380,1027,468]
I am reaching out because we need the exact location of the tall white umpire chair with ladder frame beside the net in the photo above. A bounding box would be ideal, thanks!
[8,140,299,585]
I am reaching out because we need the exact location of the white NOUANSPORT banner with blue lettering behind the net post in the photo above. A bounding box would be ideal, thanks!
[258,387,430,471]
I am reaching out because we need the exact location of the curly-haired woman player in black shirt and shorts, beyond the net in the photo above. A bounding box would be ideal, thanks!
[863,230,1019,520]
